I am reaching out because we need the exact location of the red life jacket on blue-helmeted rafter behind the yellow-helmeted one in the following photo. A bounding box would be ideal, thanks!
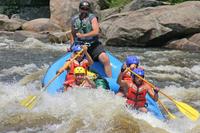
[65,59,88,81]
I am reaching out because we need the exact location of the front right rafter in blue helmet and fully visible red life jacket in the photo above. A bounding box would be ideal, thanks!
[119,68,159,112]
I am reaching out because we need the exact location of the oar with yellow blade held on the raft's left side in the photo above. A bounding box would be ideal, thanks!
[20,50,83,109]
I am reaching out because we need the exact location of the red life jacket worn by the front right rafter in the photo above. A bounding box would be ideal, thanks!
[126,83,147,108]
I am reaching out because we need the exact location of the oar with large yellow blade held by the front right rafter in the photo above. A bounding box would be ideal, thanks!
[128,68,200,121]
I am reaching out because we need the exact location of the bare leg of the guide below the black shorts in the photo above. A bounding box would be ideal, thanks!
[98,52,112,77]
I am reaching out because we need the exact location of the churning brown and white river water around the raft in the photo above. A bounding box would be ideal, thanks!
[0,37,200,133]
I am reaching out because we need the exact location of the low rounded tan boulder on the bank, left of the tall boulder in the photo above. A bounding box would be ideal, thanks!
[22,18,61,32]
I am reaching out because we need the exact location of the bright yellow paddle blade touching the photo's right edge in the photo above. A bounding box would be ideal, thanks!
[174,100,200,121]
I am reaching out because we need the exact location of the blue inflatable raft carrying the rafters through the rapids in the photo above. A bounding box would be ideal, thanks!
[42,52,165,120]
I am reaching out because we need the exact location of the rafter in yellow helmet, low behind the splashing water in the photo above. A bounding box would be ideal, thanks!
[64,67,96,91]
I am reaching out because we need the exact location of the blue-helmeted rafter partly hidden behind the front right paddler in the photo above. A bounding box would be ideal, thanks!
[116,55,140,96]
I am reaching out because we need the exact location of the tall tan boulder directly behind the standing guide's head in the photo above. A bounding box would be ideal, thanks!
[50,0,100,30]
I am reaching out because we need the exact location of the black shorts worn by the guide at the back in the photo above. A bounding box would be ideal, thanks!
[88,42,105,61]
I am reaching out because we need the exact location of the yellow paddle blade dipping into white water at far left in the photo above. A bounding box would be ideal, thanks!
[20,96,37,109]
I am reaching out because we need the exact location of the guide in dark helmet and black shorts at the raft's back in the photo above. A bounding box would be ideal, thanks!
[70,1,112,77]
